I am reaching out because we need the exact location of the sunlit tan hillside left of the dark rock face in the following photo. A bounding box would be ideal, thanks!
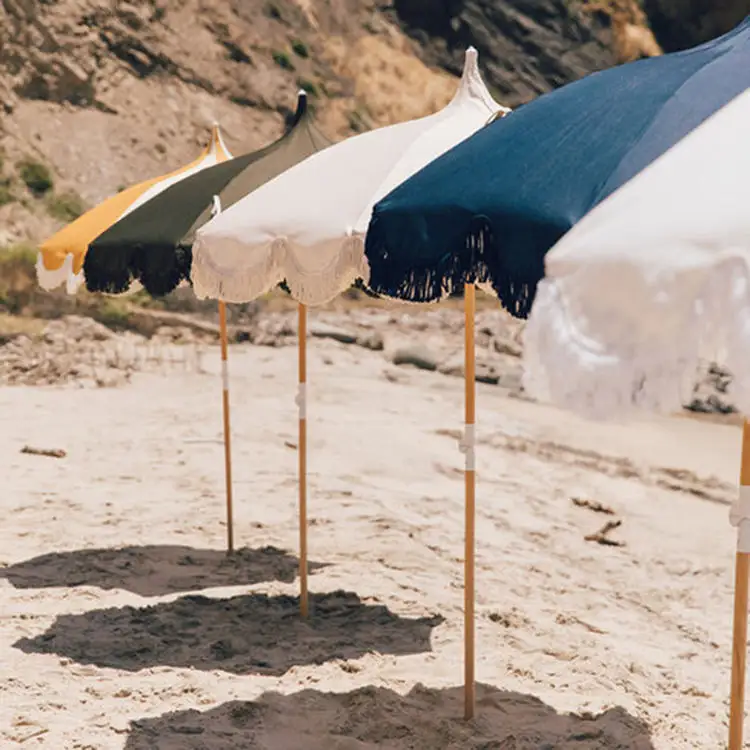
[0,0,464,246]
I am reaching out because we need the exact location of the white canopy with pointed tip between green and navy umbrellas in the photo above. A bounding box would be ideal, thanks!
[192,49,507,305]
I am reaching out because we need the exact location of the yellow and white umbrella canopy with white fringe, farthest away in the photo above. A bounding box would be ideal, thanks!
[36,125,231,292]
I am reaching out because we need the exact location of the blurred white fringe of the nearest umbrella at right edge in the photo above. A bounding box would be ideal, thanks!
[523,268,750,419]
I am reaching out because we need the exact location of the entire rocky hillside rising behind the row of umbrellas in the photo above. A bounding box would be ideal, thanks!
[0,0,744,246]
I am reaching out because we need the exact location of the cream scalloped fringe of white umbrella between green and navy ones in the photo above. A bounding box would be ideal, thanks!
[190,236,369,305]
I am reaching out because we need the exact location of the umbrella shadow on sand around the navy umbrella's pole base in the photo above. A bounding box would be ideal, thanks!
[125,685,654,750]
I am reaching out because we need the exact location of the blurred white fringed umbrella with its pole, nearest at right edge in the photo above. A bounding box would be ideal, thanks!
[524,90,750,750]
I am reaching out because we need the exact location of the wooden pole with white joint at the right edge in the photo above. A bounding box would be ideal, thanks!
[729,420,750,750]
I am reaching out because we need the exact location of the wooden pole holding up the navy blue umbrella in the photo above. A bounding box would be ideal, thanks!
[462,284,476,719]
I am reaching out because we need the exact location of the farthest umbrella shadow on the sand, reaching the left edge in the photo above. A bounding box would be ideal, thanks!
[0,545,326,596]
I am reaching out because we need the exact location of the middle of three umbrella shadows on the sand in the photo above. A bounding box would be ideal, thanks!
[14,591,443,676]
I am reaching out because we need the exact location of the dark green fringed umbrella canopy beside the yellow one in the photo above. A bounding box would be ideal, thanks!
[84,91,330,295]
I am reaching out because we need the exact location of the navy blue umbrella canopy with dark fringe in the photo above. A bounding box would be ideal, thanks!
[367,19,750,317]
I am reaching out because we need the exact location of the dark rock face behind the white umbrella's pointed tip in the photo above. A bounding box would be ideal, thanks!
[394,0,660,106]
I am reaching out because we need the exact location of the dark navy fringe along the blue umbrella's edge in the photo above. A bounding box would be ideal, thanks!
[366,217,537,318]
